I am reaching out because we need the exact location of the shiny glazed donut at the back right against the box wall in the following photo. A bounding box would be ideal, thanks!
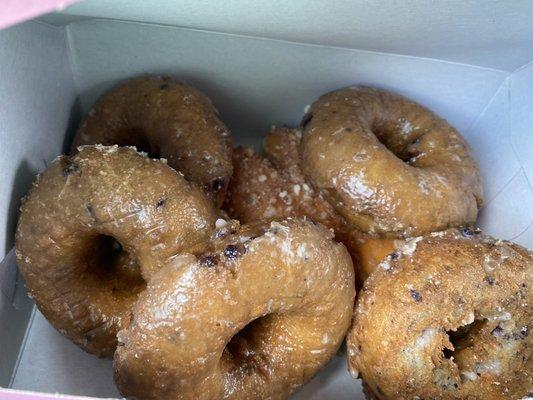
[301,87,482,236]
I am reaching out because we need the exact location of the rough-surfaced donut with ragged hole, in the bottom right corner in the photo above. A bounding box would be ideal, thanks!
[347,229,533,400]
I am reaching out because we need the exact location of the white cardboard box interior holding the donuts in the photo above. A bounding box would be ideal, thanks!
[0,0,533,400]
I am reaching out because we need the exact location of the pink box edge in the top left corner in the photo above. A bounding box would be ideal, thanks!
[0,0,79,29]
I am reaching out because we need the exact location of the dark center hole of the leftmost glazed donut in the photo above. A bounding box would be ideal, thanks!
[85,235,145,296]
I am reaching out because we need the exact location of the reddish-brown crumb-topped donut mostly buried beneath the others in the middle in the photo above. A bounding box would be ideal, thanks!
[224,127,401,285]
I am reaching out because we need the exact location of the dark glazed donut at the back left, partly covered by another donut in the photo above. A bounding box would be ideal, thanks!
[72,76,232,205]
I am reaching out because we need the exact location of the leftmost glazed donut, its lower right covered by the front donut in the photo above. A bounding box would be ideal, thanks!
[15,146,216,356]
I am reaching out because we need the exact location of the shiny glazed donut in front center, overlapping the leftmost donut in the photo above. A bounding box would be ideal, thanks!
[114,219,355,400]
